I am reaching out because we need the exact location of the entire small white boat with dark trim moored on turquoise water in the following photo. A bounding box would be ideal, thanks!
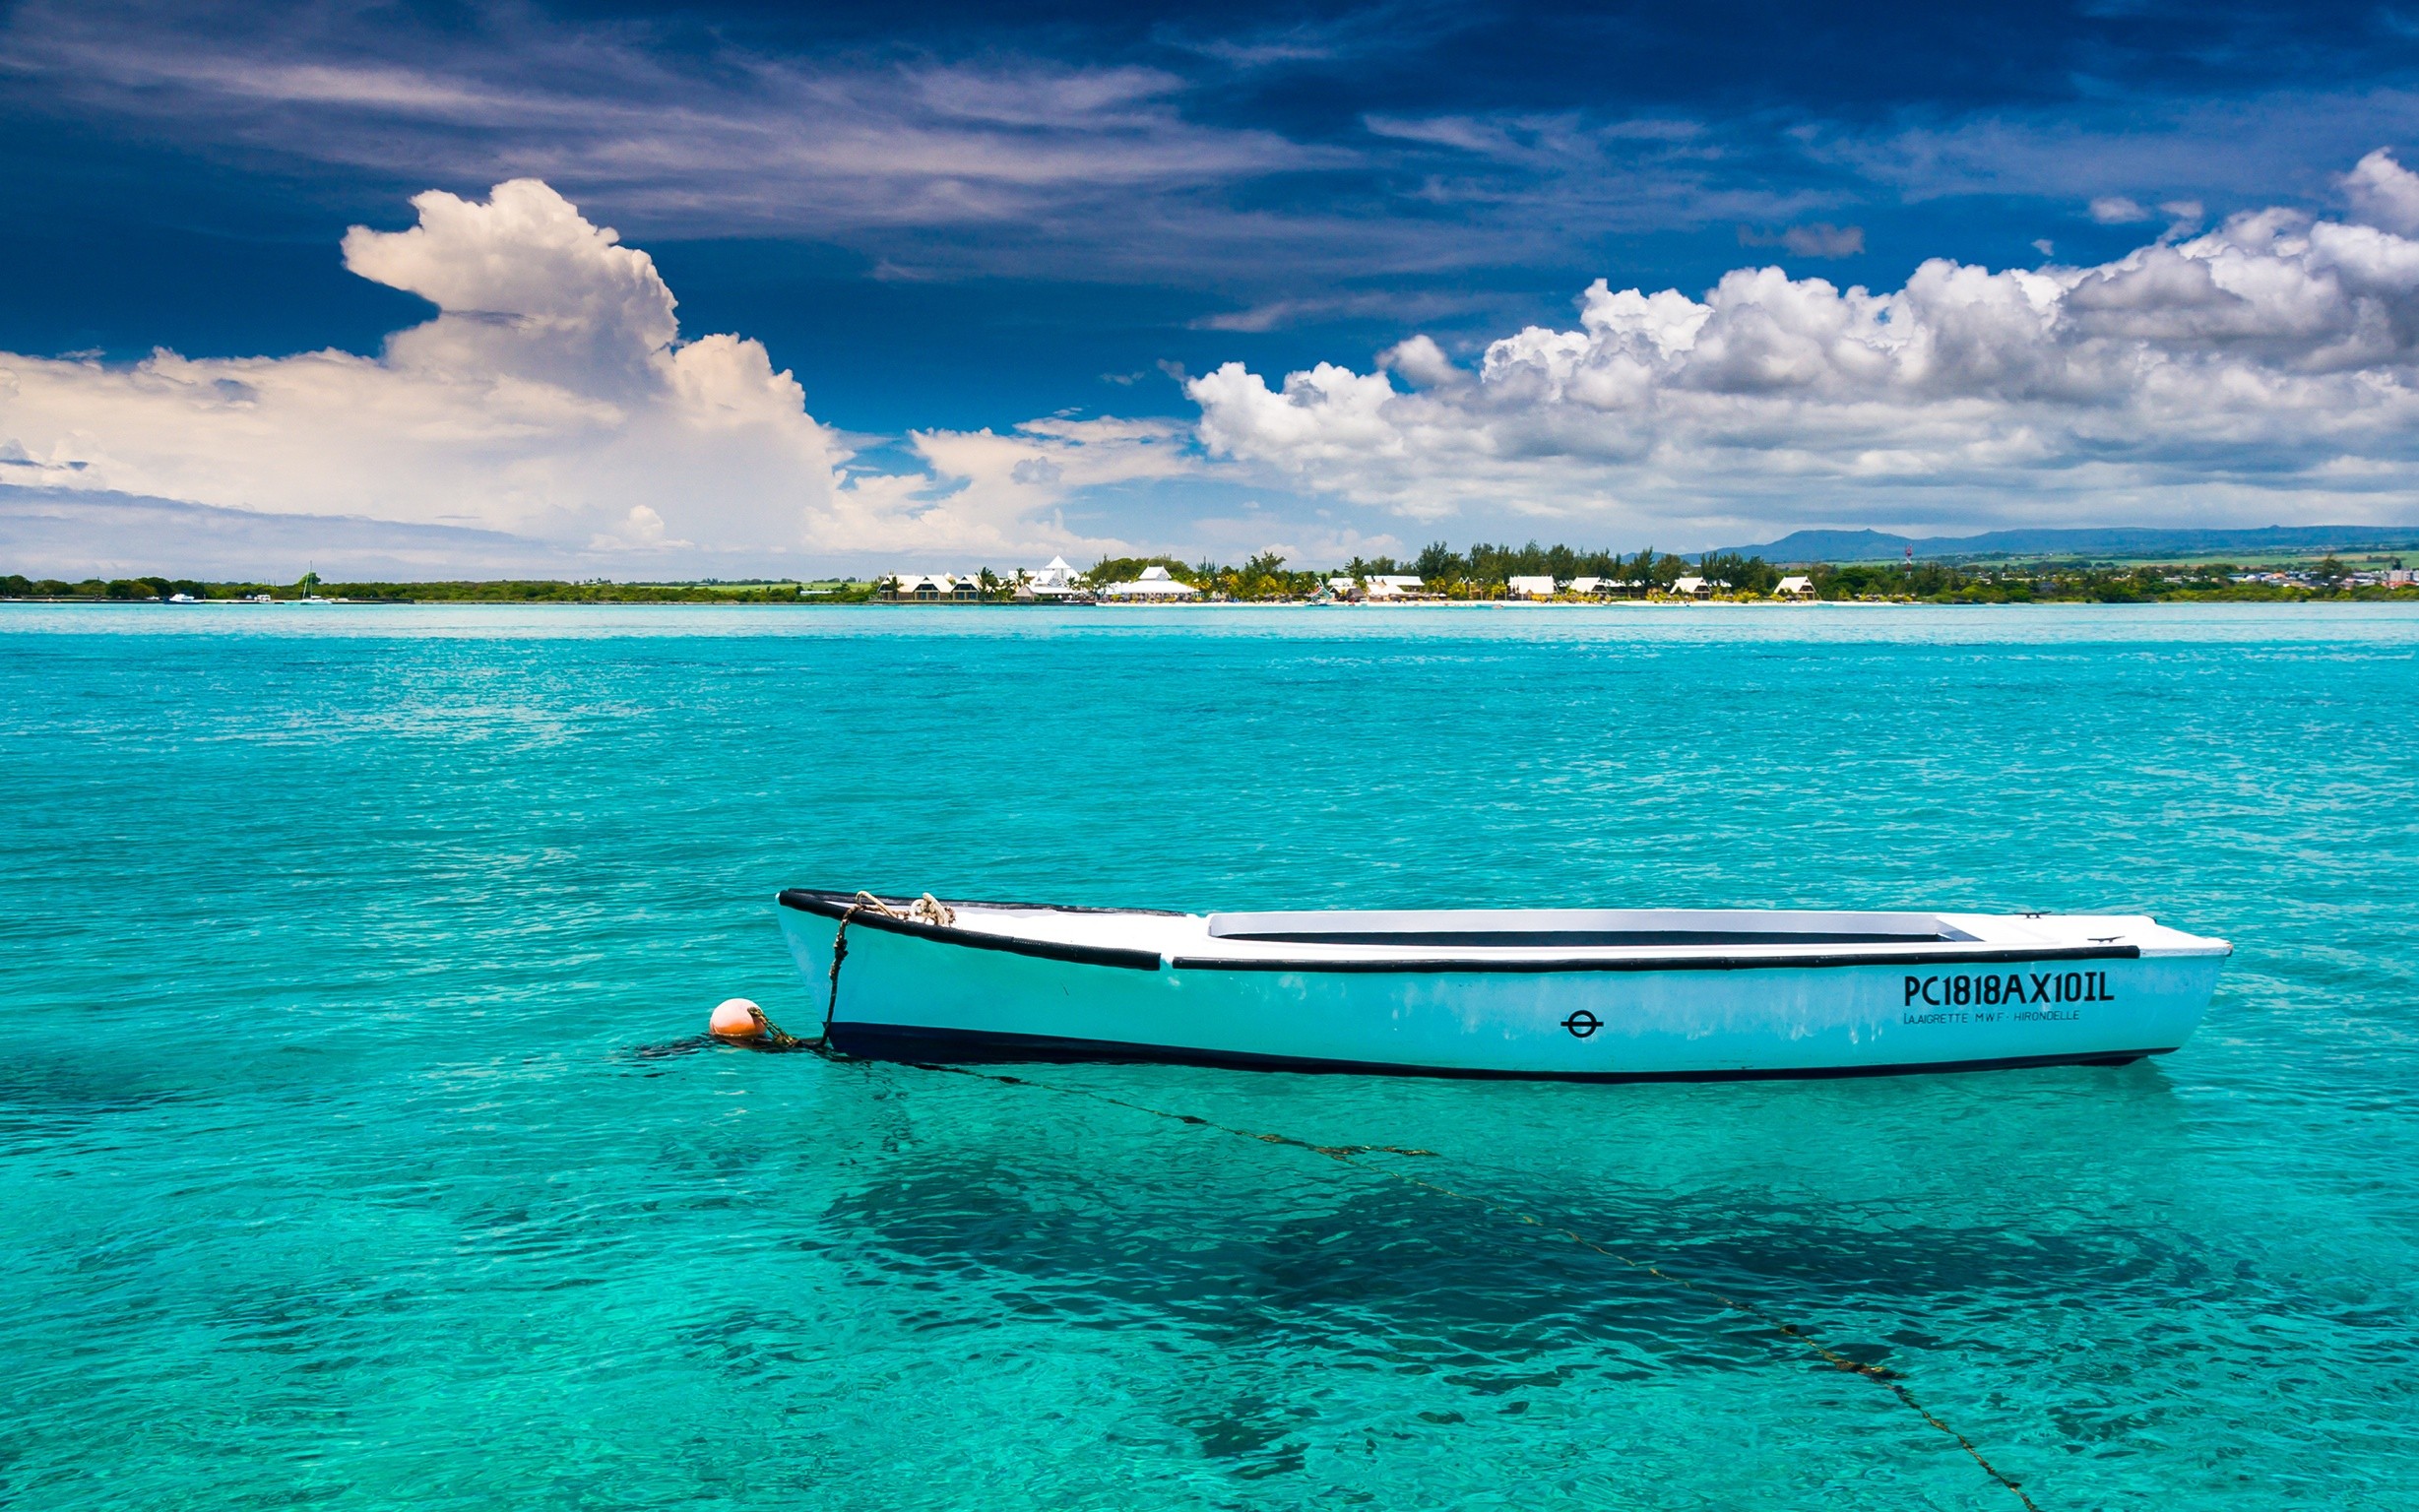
[779,888,2233,1082]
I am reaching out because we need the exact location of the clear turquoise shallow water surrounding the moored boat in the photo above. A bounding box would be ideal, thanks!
[0,607,2419,1510]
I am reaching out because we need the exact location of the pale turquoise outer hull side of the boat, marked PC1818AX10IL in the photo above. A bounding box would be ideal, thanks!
[782,890,2223,1082]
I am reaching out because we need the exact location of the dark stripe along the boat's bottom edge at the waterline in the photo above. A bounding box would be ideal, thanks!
[827,1024,2175,1082]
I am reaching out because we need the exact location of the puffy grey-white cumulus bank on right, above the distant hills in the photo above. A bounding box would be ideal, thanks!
[1187,155,2419,533]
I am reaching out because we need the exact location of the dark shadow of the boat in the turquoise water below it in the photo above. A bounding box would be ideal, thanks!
[822,1132,2276,1394]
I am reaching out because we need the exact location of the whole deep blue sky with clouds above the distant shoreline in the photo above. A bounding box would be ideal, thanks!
[0,2,2419,576]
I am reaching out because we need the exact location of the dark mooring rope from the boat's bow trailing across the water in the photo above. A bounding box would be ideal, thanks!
[757,986,2042,1512]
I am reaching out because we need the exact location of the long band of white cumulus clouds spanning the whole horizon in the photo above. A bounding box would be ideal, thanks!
[14,150,2419,576]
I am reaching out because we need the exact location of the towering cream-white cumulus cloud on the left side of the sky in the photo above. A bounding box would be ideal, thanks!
[0,179,1182,566]
